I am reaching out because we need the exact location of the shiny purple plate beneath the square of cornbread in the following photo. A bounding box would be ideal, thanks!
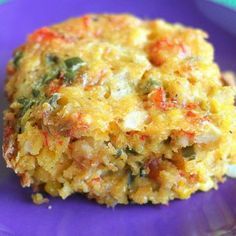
[0,0,236,236]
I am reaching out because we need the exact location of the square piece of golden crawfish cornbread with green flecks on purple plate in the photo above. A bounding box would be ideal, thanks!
[3,15,236,205]
